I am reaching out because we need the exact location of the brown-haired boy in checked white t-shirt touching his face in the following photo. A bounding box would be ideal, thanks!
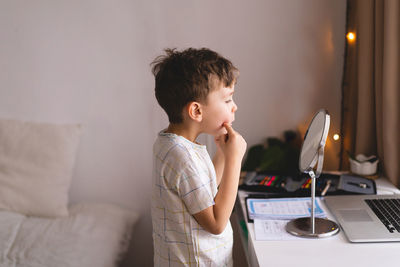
[151,48,246,267]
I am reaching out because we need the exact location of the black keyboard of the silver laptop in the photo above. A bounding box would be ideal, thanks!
[365,198,400,233]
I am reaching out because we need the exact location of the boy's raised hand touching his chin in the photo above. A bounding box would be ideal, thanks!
[215,123,247,160]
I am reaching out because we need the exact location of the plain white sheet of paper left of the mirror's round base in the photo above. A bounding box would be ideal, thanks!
[254,219,300,241]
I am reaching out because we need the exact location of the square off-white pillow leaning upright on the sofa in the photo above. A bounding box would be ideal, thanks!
[0,119,81,217]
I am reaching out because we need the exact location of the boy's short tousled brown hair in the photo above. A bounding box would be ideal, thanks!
[151,48,239,123]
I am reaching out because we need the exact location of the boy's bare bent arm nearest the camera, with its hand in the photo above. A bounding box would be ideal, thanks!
[193,125,246,234]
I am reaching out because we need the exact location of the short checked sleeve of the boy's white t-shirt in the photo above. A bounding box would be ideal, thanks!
[177,164,215,217]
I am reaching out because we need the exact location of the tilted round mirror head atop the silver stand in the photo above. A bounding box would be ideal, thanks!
[299,109,330,175]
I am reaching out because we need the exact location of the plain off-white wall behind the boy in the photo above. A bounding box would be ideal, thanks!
[0,0,346,266]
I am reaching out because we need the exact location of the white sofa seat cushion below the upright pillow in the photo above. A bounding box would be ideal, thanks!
[0,204,137,267]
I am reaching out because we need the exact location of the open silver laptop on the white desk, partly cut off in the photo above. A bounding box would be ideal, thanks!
[325,195,400,242]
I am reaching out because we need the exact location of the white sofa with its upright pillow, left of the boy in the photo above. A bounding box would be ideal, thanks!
[0,119,138,267]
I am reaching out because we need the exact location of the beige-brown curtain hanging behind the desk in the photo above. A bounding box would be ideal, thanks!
[340,0,400,187]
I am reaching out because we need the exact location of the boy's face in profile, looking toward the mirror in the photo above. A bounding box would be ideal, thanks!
[202,84,237,136]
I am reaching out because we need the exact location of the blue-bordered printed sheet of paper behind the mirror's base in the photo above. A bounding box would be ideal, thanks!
[247,198,326,220]
